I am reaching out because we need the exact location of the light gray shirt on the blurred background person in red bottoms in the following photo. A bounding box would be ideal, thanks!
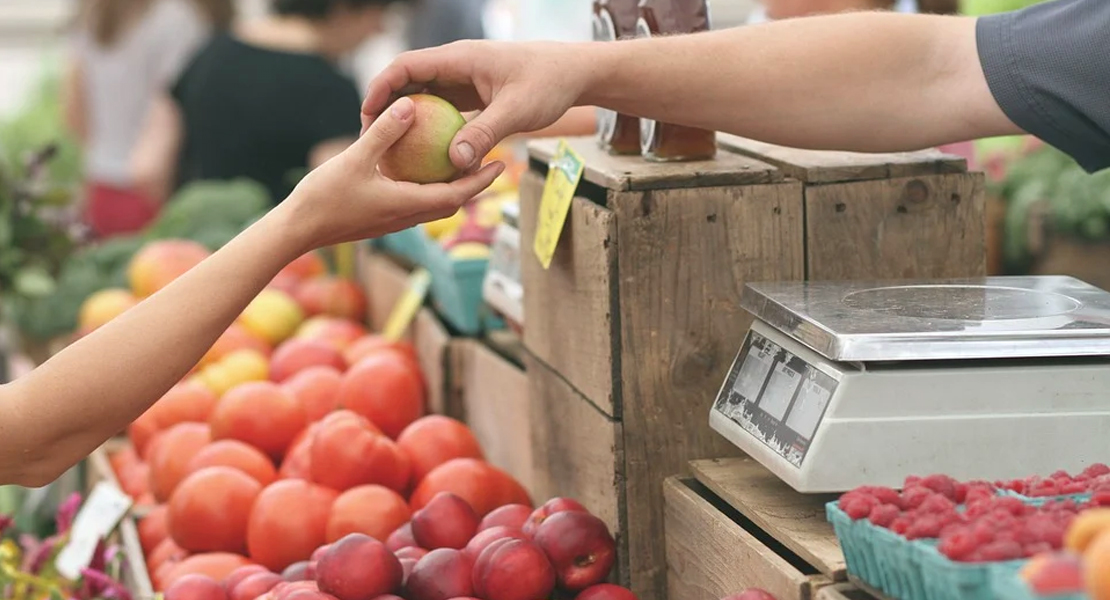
[73,0,209,186]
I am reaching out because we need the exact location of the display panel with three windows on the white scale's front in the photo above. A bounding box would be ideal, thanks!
[714,330,837,468]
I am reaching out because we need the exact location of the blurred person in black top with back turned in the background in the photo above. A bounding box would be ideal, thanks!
[132,0,408,203]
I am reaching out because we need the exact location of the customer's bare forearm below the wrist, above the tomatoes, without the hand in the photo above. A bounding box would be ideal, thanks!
[0,207,306,484]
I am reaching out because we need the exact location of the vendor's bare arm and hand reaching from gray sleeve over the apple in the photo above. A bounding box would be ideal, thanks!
[363,12,1019,170]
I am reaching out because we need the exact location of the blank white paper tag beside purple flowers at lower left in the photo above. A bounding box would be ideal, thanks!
[54,481,131,580]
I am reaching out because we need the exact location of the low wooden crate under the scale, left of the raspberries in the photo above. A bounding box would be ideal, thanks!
[664,457,852,600]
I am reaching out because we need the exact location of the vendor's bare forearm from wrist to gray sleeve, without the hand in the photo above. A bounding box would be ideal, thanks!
[581,13,1018,152]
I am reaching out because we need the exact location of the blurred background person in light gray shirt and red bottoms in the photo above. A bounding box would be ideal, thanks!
[62,0,232,237]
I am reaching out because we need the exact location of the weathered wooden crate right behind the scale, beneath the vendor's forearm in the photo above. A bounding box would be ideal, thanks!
[718,134,987,279]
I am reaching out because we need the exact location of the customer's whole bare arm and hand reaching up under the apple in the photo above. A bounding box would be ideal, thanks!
[0,95,503,487]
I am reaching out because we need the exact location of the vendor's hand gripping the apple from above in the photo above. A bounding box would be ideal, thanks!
[362,41,591,169]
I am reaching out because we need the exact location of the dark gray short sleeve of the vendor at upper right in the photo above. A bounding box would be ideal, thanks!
[976,0,1110,172]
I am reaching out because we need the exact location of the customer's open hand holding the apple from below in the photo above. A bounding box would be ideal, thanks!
[279,98,505,252]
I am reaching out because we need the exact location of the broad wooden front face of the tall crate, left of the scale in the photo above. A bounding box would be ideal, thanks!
[617,176,804,599]
